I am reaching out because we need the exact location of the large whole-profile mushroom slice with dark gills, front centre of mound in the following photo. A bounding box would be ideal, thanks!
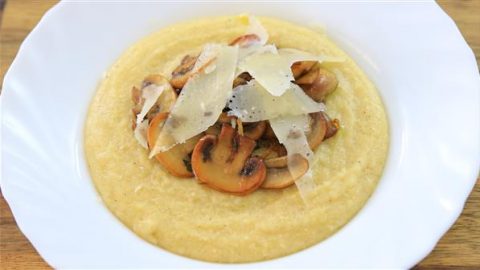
[192,124,266,195]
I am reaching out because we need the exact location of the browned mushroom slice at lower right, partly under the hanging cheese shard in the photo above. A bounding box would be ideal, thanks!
[262,154,308,189]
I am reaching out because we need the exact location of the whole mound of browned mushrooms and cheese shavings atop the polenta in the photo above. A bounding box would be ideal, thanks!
[132,17,342,196]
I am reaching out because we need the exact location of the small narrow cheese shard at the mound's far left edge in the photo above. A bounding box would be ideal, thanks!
[133,84,165,149]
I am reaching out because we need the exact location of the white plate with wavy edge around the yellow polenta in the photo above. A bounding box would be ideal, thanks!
[1,1,480,268]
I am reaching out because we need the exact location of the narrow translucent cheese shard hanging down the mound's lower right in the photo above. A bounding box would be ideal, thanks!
[270,115,315,201]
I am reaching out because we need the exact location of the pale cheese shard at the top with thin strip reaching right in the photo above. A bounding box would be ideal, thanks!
[238,48,342,96]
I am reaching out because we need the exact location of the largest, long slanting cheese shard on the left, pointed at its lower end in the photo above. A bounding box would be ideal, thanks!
[150,44,238,157]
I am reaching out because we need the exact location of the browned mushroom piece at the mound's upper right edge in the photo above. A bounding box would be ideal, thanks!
[295,66,338,102]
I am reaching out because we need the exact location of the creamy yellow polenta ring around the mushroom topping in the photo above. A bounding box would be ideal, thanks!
[85,17,388,262]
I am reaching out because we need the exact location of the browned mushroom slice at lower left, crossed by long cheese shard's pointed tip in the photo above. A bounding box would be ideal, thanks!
[147,113,203,178]
